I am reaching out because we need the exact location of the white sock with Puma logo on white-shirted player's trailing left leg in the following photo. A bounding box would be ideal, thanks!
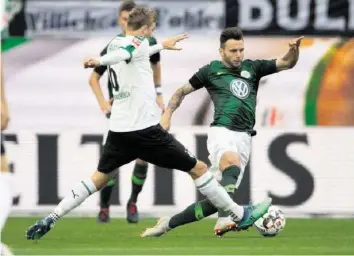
[50,179,97,221]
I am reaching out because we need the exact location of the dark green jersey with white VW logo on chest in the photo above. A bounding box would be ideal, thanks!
[189,59,276,131]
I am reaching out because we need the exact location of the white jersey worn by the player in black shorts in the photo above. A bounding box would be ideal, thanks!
[107,36,161,132]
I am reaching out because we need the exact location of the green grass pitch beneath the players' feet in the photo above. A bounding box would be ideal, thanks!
[2,217,354,255]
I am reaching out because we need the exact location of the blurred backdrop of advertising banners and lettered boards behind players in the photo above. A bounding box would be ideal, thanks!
[1,0,354,217]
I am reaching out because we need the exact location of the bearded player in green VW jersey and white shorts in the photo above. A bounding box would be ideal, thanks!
[141,27,303,237]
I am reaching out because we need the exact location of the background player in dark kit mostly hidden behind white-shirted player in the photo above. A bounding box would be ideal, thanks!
[90,0,165,223]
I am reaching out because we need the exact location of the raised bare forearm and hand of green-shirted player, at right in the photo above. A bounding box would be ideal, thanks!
[276,36,304,71]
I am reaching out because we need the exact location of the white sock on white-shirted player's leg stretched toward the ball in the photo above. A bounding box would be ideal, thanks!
[194,171,244,221]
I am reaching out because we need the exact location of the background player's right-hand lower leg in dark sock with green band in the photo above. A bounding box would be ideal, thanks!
[126,159,148,223]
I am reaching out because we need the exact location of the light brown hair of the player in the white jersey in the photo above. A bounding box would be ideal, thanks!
[128,6,156,30]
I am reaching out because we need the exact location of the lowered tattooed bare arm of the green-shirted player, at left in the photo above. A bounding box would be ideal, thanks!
[161,83,196,130]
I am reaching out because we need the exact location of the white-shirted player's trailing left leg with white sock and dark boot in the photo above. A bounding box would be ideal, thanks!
[26,171,116,240]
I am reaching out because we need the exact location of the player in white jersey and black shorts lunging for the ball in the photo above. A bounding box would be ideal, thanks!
[26,7,271,240]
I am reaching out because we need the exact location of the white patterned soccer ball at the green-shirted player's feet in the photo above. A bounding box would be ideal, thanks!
[255,205,285,237]
